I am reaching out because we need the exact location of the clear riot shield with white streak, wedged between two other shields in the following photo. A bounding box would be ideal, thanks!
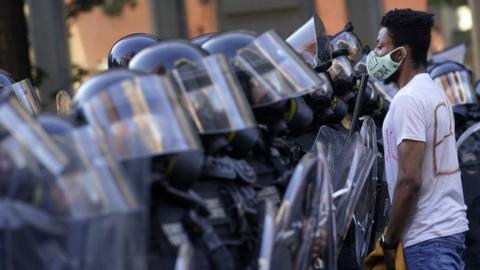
[317,126,375,246]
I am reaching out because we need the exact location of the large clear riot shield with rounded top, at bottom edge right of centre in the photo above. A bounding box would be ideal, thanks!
[271,144,337,269]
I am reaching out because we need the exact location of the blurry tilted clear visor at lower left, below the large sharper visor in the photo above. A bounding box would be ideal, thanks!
[61,126,141,216]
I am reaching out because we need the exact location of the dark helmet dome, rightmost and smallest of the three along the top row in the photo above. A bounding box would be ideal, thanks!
[201,31,256,59]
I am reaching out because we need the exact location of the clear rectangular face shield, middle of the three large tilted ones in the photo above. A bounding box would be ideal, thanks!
[173,55,256,134]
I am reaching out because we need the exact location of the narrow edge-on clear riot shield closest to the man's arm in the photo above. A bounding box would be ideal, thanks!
[353,116,378,266]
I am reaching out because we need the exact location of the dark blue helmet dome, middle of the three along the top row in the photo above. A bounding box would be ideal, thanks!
[128,40,207,74]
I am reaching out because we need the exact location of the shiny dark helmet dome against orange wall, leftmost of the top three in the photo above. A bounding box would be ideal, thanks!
[108,33,160,68]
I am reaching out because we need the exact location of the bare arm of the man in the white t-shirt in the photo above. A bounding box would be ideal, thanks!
[385,140,425,245]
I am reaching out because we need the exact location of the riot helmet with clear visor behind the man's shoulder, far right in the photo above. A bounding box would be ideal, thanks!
[429,61,478,105]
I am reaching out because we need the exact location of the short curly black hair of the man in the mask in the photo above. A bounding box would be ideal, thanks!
[380,8,435,66]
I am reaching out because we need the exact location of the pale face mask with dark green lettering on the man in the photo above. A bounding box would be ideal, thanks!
[367,47,406,82]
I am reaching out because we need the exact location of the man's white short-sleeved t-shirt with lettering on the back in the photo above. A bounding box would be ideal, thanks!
[382,73,468,247]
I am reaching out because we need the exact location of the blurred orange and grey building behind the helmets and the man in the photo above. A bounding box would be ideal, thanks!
[68,0,473,83]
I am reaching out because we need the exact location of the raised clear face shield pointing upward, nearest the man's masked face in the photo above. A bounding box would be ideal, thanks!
[286,15,332,68]
